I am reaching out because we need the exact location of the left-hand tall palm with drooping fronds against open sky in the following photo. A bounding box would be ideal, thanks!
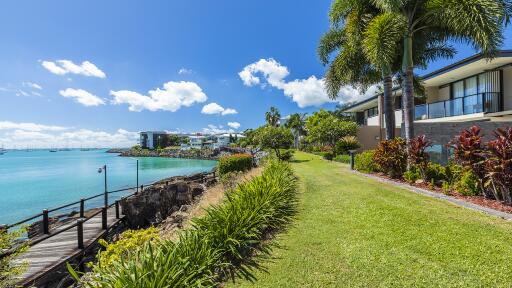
[318,0,454,139]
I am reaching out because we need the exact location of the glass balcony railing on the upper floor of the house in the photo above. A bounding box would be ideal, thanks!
[415,92,501,120]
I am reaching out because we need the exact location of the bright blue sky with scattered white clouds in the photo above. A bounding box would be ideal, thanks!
[0,0,512,147]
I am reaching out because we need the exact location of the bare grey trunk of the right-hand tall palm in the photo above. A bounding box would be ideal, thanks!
[402,34,414,143]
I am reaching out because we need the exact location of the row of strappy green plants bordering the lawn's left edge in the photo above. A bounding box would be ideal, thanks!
[77,160,297,287]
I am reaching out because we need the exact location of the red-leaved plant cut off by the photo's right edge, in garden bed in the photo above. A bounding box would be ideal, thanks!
[485,128,512,204]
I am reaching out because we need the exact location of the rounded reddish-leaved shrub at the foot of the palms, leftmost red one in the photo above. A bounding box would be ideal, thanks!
[373,138,407,178]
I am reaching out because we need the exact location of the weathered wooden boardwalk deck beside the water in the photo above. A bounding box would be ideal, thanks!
[17,207,120,285]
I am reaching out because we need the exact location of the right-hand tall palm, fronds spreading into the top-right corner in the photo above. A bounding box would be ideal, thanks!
[373,0,512,141]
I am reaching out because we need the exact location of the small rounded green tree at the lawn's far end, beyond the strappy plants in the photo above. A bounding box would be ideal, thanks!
[256,125,293,160]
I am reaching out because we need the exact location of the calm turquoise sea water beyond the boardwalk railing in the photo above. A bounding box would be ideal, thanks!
[0,150,216,224]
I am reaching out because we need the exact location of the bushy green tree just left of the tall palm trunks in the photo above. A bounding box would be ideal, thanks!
[306,109,357,156]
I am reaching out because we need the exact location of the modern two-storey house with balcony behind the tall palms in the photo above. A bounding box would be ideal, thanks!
[343,50,512,158]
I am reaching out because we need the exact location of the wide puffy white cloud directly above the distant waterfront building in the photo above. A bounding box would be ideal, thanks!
[110,81,208,112]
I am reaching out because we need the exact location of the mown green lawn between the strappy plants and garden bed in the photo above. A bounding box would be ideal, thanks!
[232,153,512,287]
